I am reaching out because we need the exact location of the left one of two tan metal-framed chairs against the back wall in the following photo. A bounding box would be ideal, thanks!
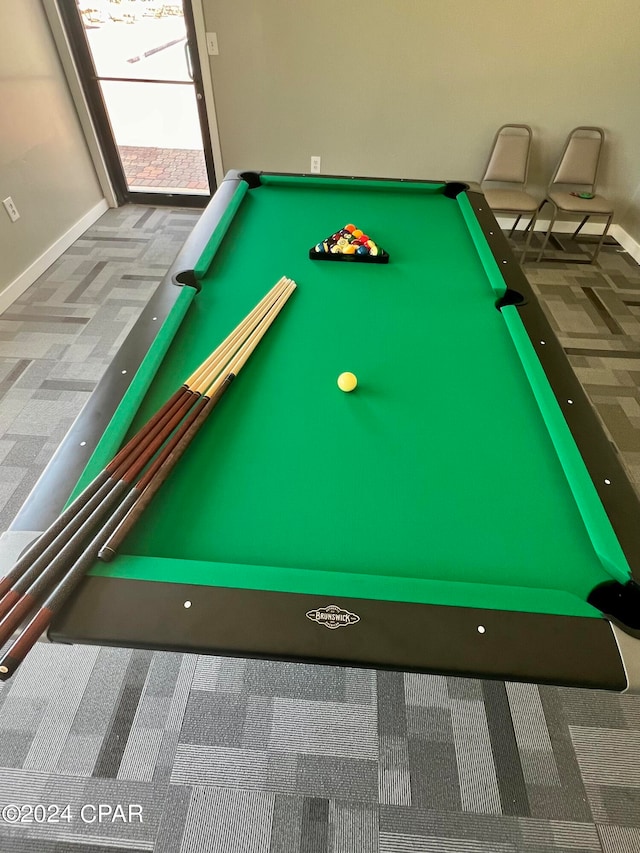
[480,124,539,262]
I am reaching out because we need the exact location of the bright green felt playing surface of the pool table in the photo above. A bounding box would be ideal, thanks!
[76,178,626,615]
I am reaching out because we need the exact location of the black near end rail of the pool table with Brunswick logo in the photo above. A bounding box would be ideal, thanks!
[43,564,640,691]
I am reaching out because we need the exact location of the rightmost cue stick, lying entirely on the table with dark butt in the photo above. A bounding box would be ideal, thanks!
[98,282,296,562]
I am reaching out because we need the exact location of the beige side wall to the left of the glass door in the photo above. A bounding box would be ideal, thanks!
[0,0,106,302]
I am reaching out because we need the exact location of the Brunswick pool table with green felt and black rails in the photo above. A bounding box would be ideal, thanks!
[5,172,640,691]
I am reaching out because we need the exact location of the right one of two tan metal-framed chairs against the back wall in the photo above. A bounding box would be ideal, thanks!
[537,127,613,264]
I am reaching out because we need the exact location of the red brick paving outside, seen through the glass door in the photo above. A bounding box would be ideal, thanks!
[119,145,209,194]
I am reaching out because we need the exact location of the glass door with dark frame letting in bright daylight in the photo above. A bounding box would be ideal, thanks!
[60,0,215,206]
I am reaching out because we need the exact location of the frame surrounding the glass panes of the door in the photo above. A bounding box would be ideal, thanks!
[42,0,224,207]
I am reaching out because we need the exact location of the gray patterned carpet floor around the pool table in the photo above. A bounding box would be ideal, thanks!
[0,206,640,853]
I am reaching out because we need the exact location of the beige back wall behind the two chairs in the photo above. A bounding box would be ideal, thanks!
[203,0,640,238]
